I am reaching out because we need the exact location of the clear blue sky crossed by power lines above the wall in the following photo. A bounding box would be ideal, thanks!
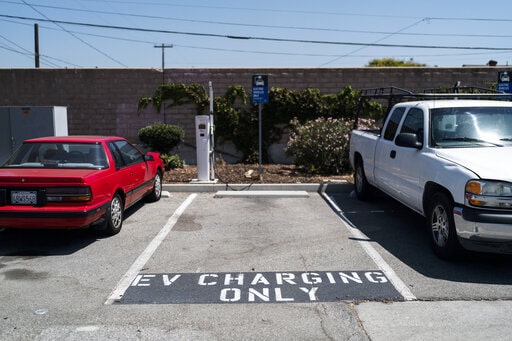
[0,0,512,69]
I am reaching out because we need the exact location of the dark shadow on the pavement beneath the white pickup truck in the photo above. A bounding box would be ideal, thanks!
[329,187,512,285]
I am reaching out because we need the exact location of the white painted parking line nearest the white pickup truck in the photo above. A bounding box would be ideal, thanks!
[321,191,417,301]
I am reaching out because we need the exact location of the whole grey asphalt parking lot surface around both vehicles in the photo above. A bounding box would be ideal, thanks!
[0,187,512,340]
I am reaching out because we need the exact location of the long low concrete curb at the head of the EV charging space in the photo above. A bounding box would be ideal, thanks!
[163,181,353,193]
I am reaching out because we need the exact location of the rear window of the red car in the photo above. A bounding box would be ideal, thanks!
[3,142,108,169]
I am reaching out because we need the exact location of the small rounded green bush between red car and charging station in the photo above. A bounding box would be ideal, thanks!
[138,123,185,154]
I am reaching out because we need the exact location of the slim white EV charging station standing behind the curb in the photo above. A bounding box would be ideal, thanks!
[191,81,217,184]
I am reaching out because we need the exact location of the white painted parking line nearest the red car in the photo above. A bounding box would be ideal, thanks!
[105,193,197,305]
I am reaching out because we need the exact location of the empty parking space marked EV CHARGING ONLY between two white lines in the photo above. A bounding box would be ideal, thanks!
[116,193,403,304]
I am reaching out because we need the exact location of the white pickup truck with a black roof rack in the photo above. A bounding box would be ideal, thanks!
[349,88,512,258]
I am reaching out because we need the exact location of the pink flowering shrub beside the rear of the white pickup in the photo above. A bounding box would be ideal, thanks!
[286,117,376,174]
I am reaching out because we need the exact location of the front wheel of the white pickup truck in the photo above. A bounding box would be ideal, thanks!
[426,193,461,259]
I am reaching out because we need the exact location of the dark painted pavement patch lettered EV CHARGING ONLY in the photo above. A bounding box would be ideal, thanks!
[119,270,404,304]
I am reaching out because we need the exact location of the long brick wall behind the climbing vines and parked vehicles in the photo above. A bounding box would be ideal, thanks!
[0,67,512,162]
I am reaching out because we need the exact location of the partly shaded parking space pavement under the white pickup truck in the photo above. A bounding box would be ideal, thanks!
[331,192,512,300]
